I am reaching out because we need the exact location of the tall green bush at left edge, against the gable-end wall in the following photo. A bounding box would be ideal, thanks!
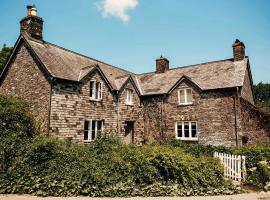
[0,95,37,172]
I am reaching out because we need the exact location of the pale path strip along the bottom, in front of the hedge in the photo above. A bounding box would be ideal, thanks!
[0,192,270,200]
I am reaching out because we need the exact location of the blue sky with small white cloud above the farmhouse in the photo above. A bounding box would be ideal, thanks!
[0,0,270,83]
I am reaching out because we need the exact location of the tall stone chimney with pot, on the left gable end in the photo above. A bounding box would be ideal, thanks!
[20,5,43,40]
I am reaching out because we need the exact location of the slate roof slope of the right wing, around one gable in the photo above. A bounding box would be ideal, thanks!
[138,58,248,95]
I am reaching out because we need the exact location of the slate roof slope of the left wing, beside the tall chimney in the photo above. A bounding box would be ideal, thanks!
[24,38,131,89]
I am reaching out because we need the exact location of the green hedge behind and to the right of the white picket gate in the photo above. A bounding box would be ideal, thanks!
[159,138,270,190]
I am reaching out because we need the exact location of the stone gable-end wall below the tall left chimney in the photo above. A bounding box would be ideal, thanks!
[0,44,51,133]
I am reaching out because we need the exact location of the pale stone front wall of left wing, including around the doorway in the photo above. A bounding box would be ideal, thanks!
[50,71,143,142]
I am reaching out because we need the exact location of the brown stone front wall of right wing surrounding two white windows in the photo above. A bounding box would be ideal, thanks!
[142,83,239,146]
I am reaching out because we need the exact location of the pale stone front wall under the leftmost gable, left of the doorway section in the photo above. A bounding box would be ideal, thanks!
[50,71,117,142]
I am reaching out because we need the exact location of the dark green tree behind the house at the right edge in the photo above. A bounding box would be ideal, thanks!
[254,82,270,114]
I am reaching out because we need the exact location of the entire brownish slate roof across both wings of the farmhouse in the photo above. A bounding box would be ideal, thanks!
[24,35,248,95]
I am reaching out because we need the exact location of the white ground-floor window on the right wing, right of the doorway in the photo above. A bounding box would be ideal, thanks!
[175,121,198,140]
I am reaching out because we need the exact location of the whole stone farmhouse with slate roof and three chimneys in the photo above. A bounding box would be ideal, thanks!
[0,6,270,146]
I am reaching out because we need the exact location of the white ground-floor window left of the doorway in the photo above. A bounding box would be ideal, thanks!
[84,120,103,142]
